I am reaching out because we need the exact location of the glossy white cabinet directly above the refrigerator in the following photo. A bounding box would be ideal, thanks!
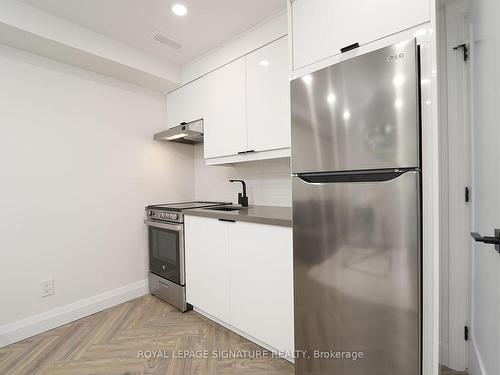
[291,0,430,70]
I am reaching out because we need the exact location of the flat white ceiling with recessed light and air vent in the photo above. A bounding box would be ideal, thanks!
[19,0,286,65]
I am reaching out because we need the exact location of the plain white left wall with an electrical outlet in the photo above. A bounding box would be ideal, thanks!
[0,45,194,332]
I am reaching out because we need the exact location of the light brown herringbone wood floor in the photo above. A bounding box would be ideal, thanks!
[0,296,293,375]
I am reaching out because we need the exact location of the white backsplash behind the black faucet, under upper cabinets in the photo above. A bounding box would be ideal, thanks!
[194,145,292,207]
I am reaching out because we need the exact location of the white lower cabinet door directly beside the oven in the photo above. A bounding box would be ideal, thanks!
[184,216,230,322]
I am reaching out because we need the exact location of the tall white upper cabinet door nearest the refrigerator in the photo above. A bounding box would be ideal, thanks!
[246,37,290,151]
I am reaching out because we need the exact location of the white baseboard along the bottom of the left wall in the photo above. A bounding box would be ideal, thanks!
[0,279,149,348]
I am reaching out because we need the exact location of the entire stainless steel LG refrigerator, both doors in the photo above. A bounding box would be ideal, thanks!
[291,40,421,375]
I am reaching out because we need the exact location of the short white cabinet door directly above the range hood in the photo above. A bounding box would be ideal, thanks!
[167,78,205,128]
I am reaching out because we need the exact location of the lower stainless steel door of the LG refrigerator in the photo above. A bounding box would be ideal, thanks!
[293,171,421,375]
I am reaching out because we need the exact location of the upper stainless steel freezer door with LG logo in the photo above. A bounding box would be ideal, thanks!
[291,40,420,173]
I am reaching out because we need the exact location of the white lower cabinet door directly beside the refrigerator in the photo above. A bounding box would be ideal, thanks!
[228,222,293,351]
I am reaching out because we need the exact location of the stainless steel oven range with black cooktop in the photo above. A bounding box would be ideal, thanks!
[144,202,227,312]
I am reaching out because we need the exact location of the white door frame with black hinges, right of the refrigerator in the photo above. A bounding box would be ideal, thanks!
[439,0,471,371]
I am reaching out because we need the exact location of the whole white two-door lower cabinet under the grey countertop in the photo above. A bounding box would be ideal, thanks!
[185,216,294,353]
